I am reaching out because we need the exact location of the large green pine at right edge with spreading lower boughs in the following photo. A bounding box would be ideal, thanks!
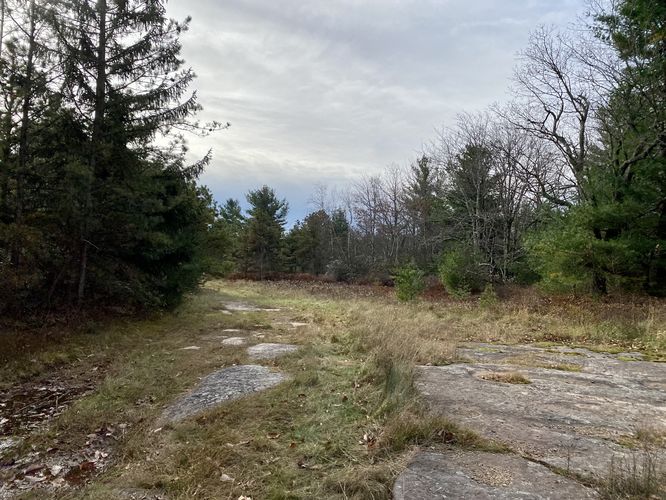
[528,0,666,293]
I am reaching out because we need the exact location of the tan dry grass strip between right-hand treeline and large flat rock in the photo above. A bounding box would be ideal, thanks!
[244,282,666,364]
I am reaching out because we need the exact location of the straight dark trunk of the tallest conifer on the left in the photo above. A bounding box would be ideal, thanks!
[77,0,107,306]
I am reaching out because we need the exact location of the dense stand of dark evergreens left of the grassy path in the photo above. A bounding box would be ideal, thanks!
[0,0,219,314]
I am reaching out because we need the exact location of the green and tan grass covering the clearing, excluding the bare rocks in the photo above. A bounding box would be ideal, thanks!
[0,281,666,500]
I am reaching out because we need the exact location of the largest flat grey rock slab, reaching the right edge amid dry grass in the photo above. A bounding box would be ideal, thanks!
[417,345,666,478]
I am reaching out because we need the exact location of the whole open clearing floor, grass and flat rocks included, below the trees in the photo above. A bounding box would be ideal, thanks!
[0,281,666,500]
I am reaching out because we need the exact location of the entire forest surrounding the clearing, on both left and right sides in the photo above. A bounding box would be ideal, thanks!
[0,0,666,315]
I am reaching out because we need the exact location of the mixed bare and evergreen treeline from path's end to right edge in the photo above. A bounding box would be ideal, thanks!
[215,0,666,295]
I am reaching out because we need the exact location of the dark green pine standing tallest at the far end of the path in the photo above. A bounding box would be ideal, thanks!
[245,186,289,279]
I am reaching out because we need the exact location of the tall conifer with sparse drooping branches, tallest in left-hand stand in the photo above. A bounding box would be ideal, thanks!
[46,0,218,305]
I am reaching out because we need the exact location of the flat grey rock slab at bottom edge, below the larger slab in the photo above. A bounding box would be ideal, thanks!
[393,451,597,500]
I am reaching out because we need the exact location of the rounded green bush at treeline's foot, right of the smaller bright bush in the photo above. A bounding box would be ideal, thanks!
[439,246,489,297]
